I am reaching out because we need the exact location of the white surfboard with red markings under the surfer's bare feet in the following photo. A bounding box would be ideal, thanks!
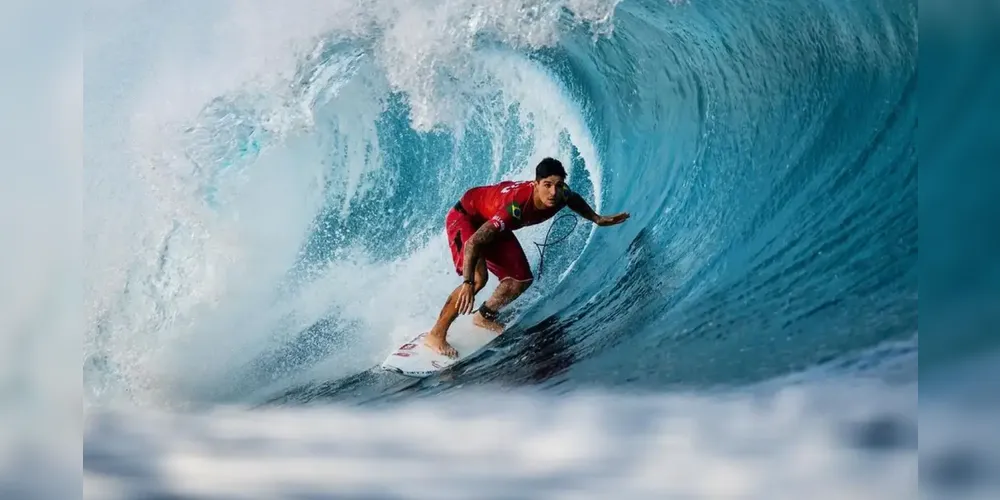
[380,321,499,377]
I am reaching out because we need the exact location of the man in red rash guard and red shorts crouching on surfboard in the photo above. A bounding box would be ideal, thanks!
[424,158,629,358]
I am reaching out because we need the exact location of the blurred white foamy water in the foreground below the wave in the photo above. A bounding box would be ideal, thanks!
[84,382,917,499]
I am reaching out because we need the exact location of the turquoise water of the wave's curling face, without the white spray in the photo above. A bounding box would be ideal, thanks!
[240,1,918,400]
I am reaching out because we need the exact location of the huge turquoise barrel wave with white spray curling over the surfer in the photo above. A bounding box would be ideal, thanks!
[84,0,918,498]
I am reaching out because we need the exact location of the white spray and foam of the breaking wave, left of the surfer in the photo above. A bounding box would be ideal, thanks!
[82,0,617,405]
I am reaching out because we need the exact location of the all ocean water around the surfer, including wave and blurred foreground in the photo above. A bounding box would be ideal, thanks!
[60,0,996,499]
